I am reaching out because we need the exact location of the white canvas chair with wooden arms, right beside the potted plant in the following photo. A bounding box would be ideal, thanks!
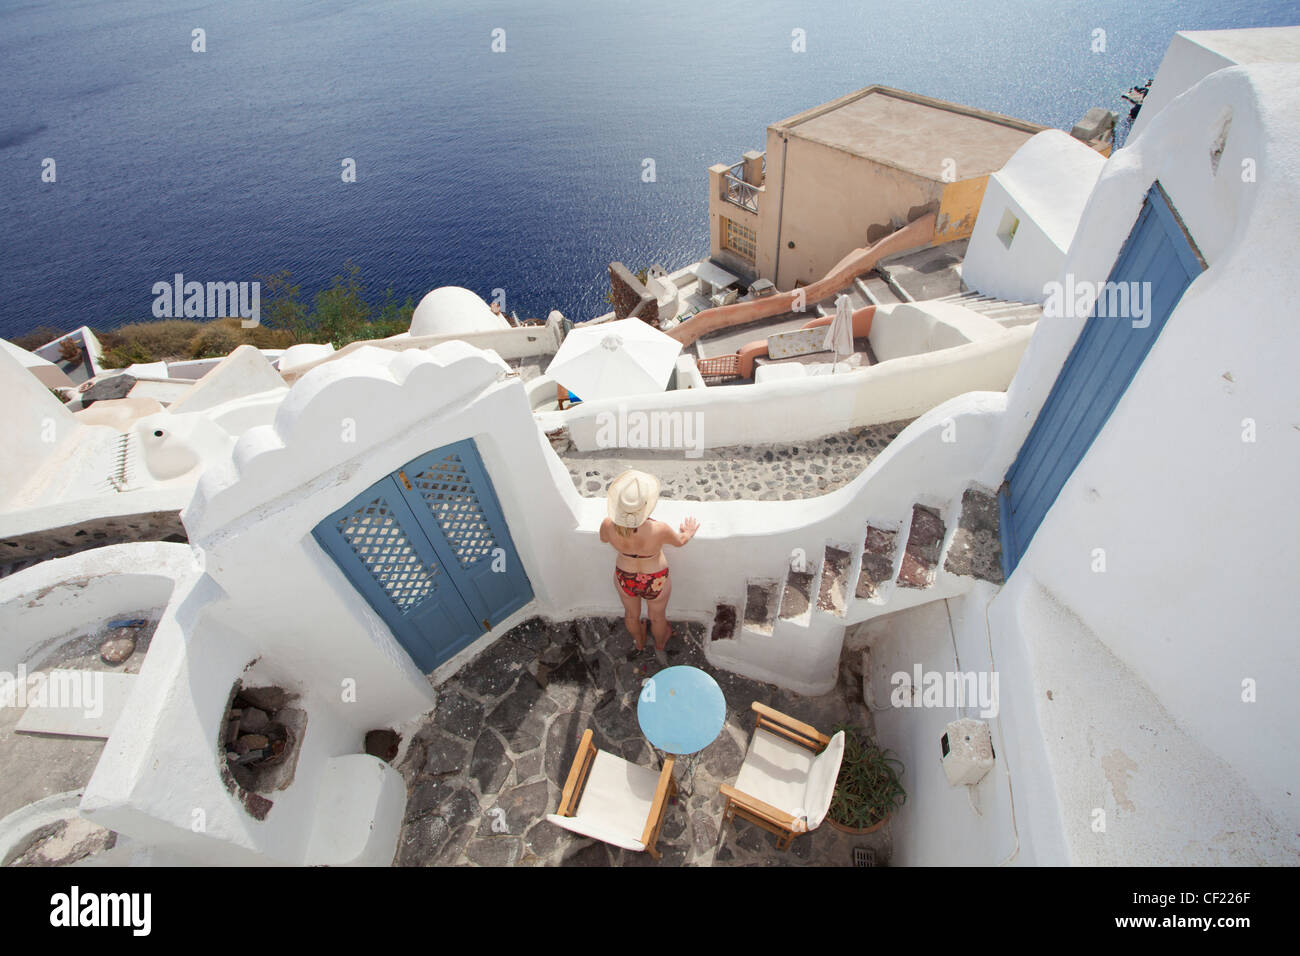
[722,701,844,849]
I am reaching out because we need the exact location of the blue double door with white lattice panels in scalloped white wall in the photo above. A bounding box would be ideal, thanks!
[312,438,533,672]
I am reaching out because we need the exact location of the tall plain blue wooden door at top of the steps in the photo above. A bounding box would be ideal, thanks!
[1000,182,1205,578]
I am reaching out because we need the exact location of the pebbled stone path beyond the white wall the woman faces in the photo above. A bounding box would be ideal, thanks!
[560,419,911,501]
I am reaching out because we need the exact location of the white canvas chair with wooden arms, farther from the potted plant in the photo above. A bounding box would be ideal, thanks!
[546,730,677,860]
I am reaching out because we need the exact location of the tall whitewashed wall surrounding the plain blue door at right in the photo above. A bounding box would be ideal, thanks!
[870,65,1300,865]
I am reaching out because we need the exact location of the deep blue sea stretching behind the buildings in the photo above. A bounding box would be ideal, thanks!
[0,0,1300,337]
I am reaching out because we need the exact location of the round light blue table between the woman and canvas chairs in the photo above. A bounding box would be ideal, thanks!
[637,666,727,792]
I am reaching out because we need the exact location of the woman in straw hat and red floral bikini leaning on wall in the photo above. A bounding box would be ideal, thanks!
[601,470,699,665]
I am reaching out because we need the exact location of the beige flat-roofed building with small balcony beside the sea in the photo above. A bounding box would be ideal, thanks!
[709,86,1044,289]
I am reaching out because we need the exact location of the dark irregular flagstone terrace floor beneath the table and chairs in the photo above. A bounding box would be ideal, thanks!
[394,619,889,866]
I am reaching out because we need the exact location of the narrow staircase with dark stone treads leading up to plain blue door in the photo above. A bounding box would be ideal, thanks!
[707,486,1002,681]
